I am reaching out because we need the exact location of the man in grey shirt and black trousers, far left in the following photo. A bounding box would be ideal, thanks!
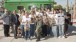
[2,9,10,37]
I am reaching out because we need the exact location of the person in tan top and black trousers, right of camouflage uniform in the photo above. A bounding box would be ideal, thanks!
[42,13,48,37]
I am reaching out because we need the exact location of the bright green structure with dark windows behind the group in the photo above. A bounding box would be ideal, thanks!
[4,0,52,11]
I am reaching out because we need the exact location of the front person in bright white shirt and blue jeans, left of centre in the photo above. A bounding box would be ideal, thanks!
[24,14,31,40]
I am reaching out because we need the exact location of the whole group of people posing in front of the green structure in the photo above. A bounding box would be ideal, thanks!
[2,8,70,41]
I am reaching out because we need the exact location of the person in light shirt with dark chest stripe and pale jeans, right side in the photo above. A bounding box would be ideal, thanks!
[58,10,65,38]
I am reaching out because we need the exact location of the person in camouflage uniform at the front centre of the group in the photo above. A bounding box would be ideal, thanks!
[35,16,42,41]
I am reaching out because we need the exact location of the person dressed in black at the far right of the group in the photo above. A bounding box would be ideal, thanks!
[64,12,72,38]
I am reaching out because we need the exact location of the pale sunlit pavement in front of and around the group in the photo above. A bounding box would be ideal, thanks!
[0,19,76,42]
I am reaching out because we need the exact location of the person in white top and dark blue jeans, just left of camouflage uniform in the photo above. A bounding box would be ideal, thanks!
[29,11,36,37]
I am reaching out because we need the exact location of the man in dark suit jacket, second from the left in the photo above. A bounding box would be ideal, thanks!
[13,10,20,39]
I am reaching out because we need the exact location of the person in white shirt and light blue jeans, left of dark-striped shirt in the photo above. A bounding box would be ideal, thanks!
[51,11,58,37]
